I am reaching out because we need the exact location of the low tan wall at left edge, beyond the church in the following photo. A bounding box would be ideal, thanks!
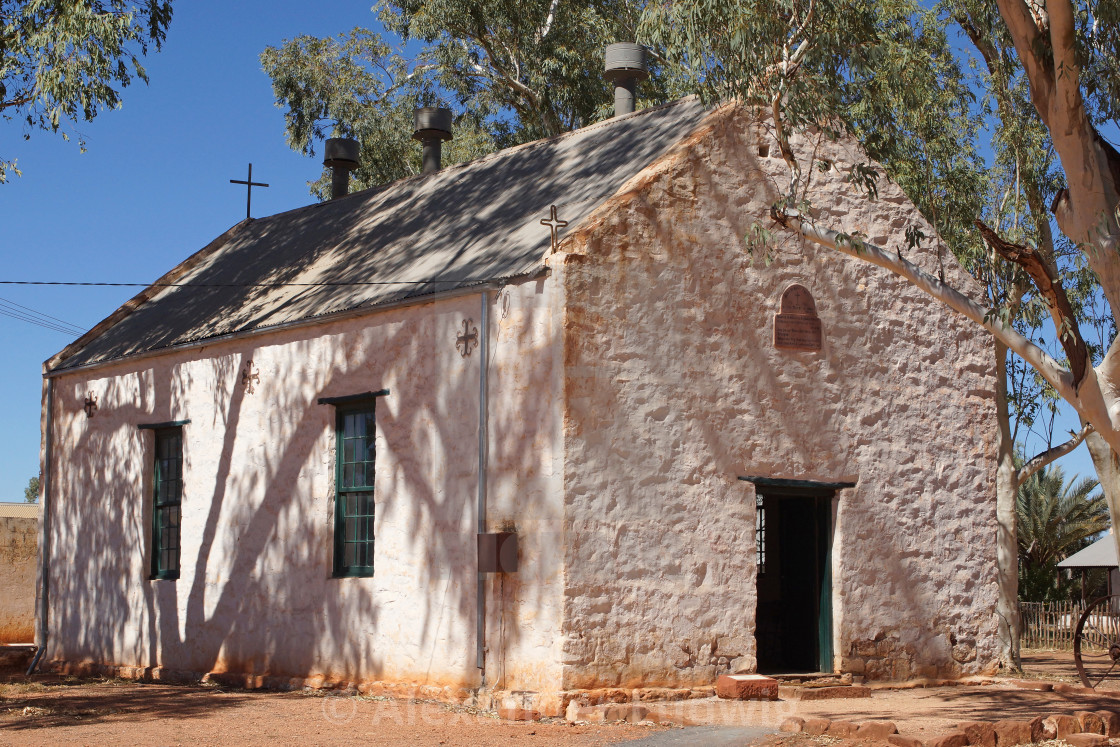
[0,516,39,643]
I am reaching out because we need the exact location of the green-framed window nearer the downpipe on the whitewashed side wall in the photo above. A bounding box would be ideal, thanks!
[335,399,376,576]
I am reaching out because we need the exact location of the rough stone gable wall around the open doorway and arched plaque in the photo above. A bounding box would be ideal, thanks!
[550,109,998,689]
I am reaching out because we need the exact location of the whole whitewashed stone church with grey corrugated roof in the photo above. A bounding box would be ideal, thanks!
[38,90,998,713]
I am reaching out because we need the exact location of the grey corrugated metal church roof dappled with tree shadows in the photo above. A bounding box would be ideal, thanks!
[54,97,706,370]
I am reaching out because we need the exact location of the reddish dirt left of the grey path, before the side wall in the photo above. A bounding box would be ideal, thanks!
[0,676,659,747]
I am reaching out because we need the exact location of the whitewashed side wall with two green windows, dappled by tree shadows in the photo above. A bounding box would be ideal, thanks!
[47,281,561,690]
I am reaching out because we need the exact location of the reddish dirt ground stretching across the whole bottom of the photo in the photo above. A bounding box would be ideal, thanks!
[0,652,1120,747]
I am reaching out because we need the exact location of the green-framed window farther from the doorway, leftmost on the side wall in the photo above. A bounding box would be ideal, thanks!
[151,428,183,579]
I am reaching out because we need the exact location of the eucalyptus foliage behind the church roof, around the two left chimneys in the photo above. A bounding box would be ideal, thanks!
[261,0,684,197]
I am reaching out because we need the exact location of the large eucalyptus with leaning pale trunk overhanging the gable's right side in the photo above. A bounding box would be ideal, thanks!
[642,0,1120,663]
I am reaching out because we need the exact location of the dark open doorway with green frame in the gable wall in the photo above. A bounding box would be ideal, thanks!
[752,478,848,674]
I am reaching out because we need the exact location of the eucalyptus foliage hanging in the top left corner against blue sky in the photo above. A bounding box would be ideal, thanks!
[0,0,171,184]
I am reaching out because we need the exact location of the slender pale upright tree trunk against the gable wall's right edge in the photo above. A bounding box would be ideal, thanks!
[995,339,1023,671]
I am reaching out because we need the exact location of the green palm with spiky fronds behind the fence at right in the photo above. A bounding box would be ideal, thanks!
[1016,467,1109,601]
